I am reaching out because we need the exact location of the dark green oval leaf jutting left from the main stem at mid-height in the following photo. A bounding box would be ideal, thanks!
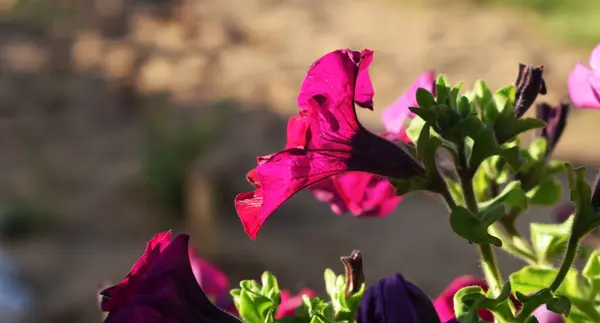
[450,206,502,247]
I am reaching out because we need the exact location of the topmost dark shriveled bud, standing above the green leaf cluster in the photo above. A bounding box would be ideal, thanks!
[515,64,546,118]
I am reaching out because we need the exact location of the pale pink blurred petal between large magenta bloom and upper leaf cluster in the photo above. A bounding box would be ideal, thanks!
[382,71,435,133]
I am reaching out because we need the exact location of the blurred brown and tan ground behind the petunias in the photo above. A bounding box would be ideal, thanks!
[0,0,600,323]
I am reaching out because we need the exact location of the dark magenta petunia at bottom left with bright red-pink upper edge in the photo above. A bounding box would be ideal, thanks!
[101,232,240,323]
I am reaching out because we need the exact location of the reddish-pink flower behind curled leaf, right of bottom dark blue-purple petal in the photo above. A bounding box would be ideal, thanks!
[433,276,494,322]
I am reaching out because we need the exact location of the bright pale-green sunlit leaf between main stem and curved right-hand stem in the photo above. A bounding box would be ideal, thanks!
[529,217,573,263]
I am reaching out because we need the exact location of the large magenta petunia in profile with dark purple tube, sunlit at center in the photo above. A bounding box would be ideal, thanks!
[235,50,424,239]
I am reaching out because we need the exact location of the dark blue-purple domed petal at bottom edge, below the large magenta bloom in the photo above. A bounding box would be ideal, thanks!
[356,274,440,323]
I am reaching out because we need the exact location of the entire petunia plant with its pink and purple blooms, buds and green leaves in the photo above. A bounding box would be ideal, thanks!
[101,45,600,323]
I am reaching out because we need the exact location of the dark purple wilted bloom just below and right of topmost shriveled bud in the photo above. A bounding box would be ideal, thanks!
[536,103,570,156]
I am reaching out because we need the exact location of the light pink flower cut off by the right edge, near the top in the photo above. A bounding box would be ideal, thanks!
[569,44,600,109]
